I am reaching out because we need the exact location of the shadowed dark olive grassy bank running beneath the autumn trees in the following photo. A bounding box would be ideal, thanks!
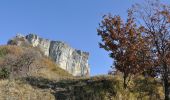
[21,76,163,100]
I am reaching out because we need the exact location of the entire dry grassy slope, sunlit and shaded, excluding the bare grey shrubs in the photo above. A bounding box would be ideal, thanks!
[0,46,165,100]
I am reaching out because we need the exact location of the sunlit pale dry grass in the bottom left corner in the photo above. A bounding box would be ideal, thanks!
[0,80,55,100]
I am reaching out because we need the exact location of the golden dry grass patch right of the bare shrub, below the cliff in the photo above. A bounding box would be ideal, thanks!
[31,57,72,80]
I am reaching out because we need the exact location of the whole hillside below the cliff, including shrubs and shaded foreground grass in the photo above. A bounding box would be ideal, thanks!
[0,45,163,100]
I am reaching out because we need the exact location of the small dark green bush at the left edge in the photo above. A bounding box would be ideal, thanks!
[0,67,10,79]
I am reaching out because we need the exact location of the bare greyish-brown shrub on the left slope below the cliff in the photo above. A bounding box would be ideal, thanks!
[0,48,42,77]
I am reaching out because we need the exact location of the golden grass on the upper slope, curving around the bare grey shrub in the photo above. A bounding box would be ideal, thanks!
[0,45,72,80]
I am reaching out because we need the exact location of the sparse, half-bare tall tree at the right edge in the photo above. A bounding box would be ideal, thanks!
[131,0,170,100]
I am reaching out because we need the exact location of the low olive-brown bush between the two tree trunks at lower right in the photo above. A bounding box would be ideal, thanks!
[131,76,163,100]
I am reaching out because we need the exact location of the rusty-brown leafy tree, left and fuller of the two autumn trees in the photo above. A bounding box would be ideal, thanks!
[98,11,151,88]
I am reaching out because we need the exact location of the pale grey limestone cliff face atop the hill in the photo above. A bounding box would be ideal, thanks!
[9,34,90,76]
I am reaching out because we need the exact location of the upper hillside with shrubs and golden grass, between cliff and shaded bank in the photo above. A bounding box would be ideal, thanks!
[0,45,72,80]
